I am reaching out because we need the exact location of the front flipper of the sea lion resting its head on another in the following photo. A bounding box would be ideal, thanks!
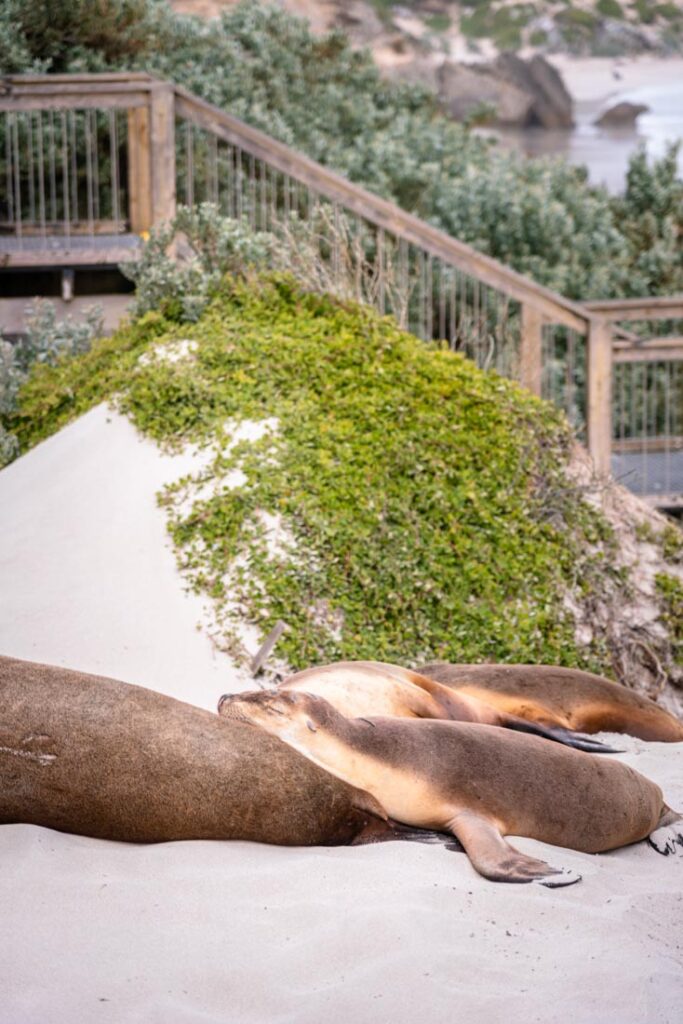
[449,811,581,889]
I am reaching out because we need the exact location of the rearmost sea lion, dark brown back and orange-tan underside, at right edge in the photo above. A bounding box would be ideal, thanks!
[418,663,683,742]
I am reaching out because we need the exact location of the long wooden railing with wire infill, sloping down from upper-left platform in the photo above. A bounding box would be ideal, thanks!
[0,74,683,501]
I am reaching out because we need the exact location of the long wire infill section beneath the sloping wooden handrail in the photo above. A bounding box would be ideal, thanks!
[176,118,520,377]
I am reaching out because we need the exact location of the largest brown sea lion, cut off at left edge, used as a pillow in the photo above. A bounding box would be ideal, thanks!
[0,657,432,846]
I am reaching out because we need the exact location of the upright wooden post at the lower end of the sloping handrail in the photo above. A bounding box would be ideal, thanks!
[586,316,612,473]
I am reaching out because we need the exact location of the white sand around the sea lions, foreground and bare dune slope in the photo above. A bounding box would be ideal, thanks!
[0,409,683,1024]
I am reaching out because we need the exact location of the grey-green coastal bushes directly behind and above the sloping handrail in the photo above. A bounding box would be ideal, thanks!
[5,0,683,298]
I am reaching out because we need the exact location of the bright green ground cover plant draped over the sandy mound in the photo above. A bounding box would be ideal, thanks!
[7,275,634,671]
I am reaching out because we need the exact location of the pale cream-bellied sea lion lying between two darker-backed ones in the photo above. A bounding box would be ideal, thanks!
[274,662,614,754]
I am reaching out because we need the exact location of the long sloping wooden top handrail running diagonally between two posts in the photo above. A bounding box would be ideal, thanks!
[175,87,589,333]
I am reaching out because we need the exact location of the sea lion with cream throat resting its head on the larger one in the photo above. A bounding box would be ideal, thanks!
[222,690,683,887]
